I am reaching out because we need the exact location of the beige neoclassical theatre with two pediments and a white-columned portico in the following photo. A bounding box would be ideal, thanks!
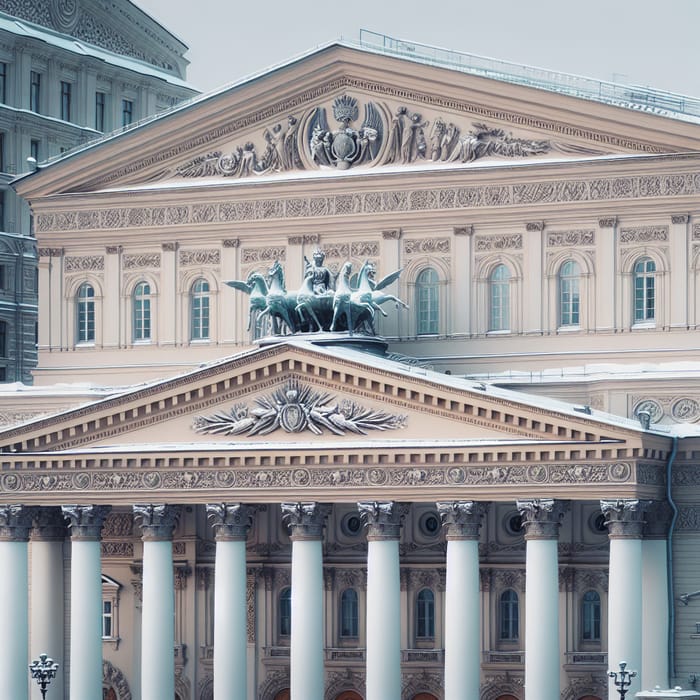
[0,37,700,700]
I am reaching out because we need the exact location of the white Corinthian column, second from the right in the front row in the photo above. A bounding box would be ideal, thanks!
[517,498,568,700]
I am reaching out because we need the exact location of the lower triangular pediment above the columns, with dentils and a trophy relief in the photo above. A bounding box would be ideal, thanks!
[0,342,636,453]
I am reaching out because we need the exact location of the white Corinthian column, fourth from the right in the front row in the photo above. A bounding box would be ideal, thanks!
[357,501,408,700]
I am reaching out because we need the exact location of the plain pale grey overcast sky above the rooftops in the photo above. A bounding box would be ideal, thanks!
[133,0,700,97]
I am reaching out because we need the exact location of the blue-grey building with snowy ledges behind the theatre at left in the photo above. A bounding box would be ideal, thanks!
[0,0,196,382]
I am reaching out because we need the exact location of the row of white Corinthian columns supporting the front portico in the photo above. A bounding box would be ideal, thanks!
[0,499,668,700]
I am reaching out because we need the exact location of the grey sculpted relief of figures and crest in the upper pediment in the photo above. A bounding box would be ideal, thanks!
[175,93,605,178]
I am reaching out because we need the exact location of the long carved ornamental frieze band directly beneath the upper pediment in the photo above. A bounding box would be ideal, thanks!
[36,172,700,232]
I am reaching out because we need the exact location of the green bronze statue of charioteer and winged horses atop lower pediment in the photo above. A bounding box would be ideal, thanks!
[226,249,408,335]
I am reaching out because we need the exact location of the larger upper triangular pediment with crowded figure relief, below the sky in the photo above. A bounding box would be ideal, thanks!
[17,45,700,198]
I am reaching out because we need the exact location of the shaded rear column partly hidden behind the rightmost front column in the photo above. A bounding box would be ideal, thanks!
[644,501,672,690]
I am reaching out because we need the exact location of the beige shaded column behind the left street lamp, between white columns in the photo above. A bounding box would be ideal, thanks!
[29,506,66,700]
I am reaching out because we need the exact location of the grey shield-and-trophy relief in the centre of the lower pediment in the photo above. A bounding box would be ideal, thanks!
[192,380,406,436]
